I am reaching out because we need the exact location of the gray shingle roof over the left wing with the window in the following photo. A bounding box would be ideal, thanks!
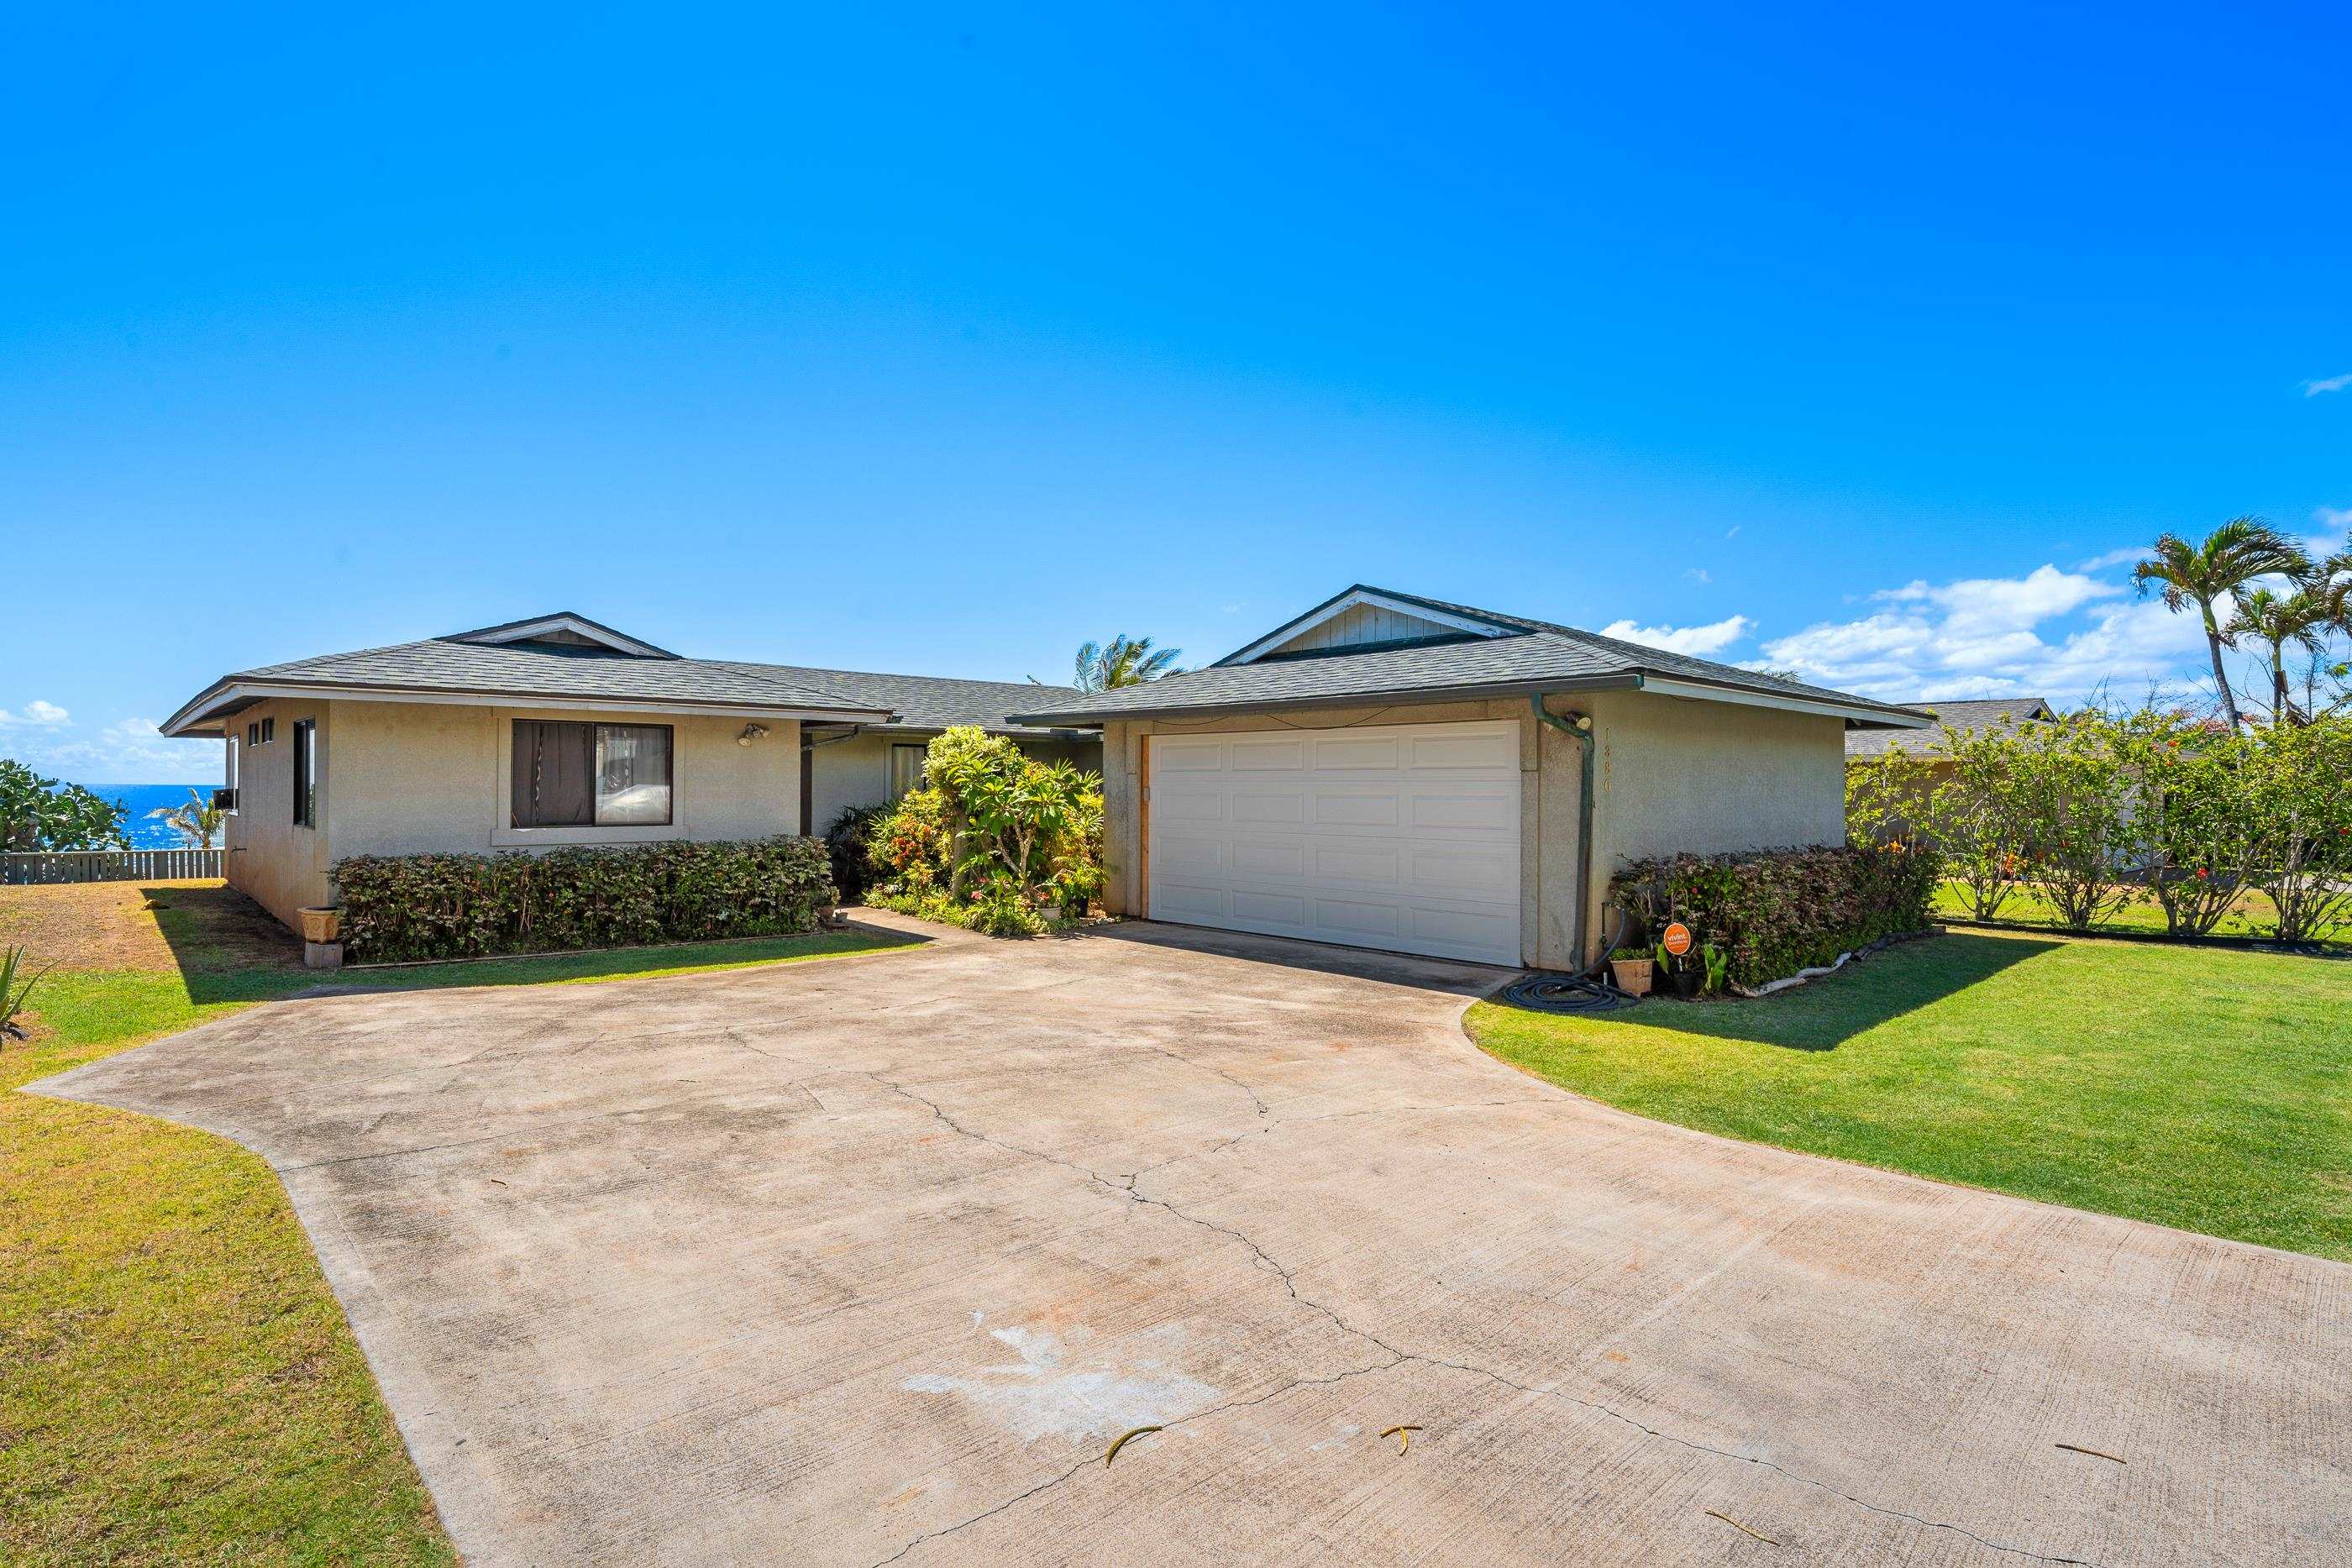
[165,627,1100,733]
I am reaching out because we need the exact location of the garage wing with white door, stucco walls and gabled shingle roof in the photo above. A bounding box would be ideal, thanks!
[1011,585,1931,968]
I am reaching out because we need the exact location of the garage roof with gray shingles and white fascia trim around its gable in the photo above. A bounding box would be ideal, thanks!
[1014,583,1929,726]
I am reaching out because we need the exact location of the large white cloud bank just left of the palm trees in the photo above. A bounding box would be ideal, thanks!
[1761,567,2206,703]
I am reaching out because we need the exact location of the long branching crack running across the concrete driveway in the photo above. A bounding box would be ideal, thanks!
[864,1081,2100,1568]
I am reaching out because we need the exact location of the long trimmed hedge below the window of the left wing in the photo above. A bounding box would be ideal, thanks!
[334,836,835,964]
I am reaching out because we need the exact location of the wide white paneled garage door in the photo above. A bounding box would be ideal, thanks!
[1150,720,1520,966]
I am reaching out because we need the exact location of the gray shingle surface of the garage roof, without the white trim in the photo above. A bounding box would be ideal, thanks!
[1016,588,1922,724]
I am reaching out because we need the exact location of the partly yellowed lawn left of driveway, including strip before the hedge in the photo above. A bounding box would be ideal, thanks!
[0,884,907,1563]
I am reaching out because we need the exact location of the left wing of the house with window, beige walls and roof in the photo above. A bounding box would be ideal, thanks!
[162,614,1100,924]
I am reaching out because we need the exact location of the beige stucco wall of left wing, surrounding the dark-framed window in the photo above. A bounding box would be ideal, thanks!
[226,700,800,924]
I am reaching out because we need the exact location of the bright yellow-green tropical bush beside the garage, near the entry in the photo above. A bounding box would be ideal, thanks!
[865,724,1103,936]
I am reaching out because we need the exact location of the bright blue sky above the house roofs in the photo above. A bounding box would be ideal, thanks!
[0,5,2352,783]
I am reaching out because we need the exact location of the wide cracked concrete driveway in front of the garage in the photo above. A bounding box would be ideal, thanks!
[27,926,2352,1563]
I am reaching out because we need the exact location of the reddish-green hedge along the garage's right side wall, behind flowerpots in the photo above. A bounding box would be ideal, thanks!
[1609,844,1940,988]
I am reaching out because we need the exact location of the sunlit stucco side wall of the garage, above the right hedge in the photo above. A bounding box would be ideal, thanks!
[1590,691,1846,941]
